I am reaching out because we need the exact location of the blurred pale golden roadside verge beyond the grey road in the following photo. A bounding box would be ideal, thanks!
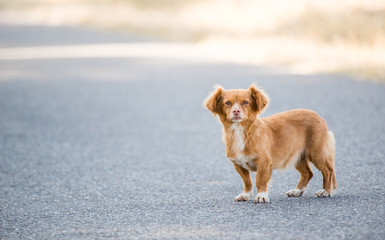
[0,0,385,81]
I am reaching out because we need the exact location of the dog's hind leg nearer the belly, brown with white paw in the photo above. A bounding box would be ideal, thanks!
[286,153,313,197]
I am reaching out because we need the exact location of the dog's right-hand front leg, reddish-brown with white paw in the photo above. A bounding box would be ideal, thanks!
[254,163,273,203]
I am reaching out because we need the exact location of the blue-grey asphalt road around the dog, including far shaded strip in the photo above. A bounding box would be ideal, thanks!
[0,26,385,239]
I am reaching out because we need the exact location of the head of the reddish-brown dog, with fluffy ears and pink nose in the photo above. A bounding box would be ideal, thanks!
[203,85,269,123]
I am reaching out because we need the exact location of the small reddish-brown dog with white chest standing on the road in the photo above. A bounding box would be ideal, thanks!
[203,84,337,203]
